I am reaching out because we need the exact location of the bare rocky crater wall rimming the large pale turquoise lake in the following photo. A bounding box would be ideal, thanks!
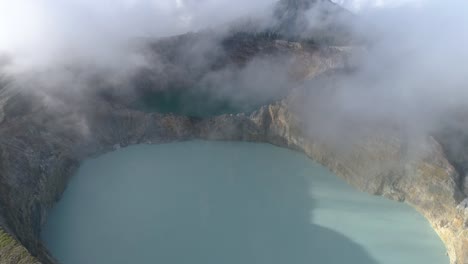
[0,96,468,264]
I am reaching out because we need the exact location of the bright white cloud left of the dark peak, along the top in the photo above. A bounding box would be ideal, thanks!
[0,0,274,70]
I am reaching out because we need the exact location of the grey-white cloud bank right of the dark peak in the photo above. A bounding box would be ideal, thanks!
[341,0,468,127]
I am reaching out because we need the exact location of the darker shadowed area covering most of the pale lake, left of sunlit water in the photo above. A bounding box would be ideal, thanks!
[41,142,377,264]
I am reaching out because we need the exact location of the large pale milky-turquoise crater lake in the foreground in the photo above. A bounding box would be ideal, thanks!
[43,141,449,264]
